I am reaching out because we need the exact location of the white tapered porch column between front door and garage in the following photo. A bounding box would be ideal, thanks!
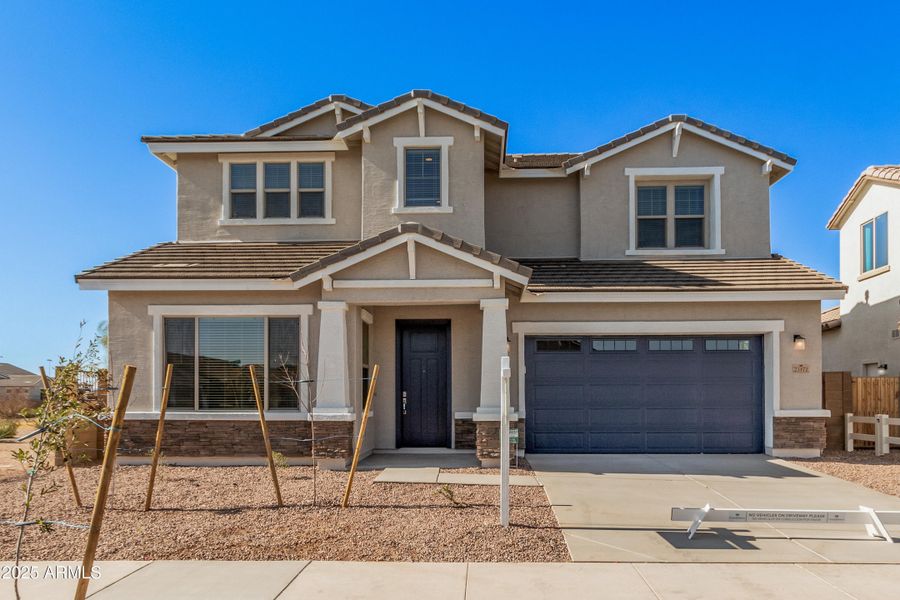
[474,298,509,421]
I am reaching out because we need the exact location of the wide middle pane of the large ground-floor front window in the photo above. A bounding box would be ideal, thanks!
[197,317,264,410]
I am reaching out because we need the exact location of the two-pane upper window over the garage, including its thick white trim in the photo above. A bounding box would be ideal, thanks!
[625,167,725,256]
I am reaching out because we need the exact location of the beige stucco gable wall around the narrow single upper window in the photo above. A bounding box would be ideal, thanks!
[362,109,484,245]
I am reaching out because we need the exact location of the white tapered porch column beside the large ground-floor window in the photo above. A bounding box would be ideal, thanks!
[315,302,353,420]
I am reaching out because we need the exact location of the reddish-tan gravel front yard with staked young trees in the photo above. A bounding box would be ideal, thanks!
[0,466,569,562]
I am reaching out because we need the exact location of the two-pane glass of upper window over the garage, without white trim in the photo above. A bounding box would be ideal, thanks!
[636,184,706,249]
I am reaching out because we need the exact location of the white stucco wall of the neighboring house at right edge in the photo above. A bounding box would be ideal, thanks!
[823,183,900,376]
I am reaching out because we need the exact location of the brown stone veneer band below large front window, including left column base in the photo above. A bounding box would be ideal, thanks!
[119,419,353,468]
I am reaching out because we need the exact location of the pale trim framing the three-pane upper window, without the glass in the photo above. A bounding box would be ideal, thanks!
[219,152,337,225]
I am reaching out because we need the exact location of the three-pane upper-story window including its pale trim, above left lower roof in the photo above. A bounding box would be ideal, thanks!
[219,153,335,225]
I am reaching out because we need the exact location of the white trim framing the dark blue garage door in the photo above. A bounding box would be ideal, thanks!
[512,320,784,452]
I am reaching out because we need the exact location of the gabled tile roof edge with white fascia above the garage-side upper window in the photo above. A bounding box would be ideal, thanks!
[562,115,797,183]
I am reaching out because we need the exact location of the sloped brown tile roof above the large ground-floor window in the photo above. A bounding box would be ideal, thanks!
[75,241,356,281]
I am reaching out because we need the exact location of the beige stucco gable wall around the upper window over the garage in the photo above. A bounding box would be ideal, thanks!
[581,132,770,259]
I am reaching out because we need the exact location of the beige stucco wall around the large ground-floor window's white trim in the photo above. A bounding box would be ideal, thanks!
[109,286,319,412]
